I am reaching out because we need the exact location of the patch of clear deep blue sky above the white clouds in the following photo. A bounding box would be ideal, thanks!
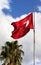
[2,0,41,18]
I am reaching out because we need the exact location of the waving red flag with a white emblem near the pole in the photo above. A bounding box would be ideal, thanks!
[11,13,33,39]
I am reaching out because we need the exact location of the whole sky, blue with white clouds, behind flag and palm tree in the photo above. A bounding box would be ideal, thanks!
[0,0,41,65]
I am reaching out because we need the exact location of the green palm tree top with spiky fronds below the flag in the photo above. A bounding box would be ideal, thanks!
[0,41,24,65]
